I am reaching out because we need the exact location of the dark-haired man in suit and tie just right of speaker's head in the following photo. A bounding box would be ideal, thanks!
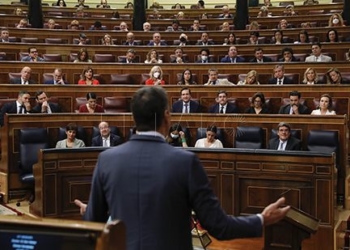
[171,87,200,114]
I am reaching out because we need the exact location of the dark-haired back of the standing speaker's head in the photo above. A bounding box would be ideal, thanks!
[131,86,168,131]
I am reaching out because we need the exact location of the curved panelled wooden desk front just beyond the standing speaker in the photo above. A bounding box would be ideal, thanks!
[30,148,337,250]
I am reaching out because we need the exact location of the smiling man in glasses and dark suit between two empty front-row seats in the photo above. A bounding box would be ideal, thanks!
[267,122,301,150]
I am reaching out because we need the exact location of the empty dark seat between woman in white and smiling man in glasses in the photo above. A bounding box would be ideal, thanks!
[234,126,264,149]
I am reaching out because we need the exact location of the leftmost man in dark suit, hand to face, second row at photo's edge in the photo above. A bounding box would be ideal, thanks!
[0,90,32,127]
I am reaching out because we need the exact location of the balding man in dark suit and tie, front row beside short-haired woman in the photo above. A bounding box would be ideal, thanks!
[91,122,123,147]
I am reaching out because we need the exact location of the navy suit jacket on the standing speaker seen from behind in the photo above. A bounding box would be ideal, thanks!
[84,135,262,250]
